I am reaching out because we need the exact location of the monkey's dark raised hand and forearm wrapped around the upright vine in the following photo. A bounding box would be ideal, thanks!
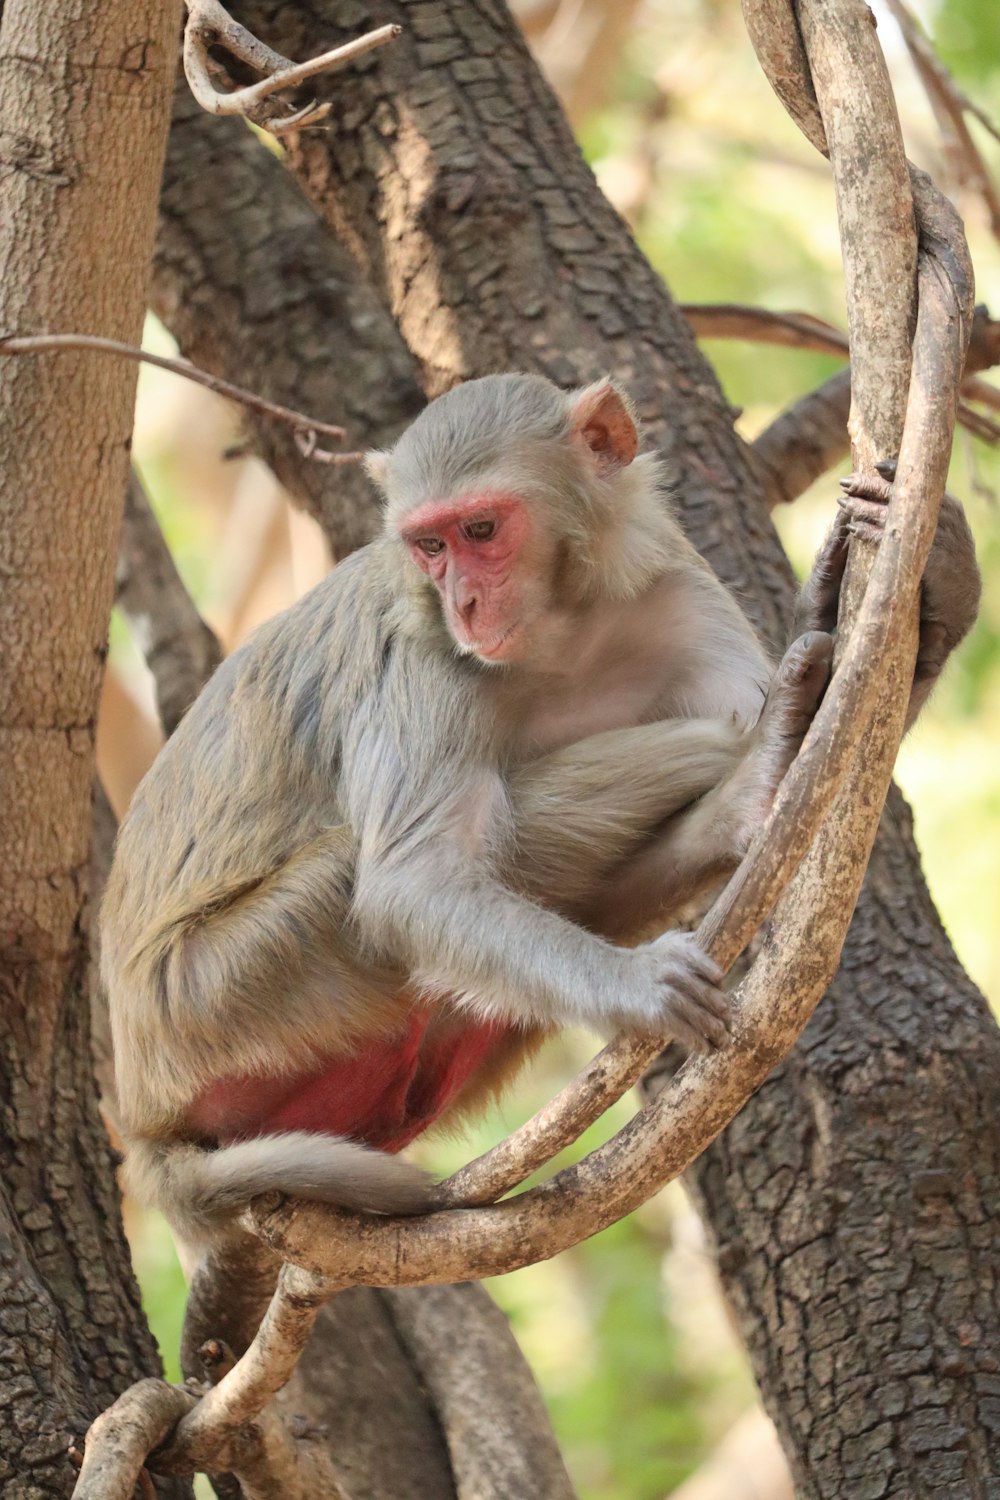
[796,461,982,729]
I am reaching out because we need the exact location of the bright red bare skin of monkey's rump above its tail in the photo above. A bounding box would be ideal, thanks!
[189,1011,507,1152]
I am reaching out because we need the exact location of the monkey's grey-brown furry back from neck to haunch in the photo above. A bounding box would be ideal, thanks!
[102,542,396,984]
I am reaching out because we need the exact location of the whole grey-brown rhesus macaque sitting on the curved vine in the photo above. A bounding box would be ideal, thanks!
[102,375,975,1238]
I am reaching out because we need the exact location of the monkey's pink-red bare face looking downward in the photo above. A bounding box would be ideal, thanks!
[399,492,532,662]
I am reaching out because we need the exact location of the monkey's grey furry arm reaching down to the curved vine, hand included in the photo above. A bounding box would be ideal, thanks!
[354,746,729,1049]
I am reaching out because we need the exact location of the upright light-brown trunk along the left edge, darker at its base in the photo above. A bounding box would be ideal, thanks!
[0,0,181,1500]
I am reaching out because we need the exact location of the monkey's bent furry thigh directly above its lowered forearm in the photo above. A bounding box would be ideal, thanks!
[510,719,747,914]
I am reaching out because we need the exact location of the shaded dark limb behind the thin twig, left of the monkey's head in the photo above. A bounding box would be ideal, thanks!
[150,78,423,557]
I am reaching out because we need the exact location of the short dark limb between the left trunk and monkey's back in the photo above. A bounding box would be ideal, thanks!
[115,470,222,735]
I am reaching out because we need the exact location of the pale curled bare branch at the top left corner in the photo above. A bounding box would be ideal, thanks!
[184,0,402,135]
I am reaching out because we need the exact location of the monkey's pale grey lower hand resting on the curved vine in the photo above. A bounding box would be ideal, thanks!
[622,932,732,1052]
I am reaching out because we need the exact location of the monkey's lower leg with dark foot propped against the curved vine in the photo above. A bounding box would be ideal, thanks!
[582,632,834,938]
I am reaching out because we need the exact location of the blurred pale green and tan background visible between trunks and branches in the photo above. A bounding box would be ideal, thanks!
[105,0,1000,1500]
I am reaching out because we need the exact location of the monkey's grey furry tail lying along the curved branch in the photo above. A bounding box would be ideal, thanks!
[124,1131,433,1233]
